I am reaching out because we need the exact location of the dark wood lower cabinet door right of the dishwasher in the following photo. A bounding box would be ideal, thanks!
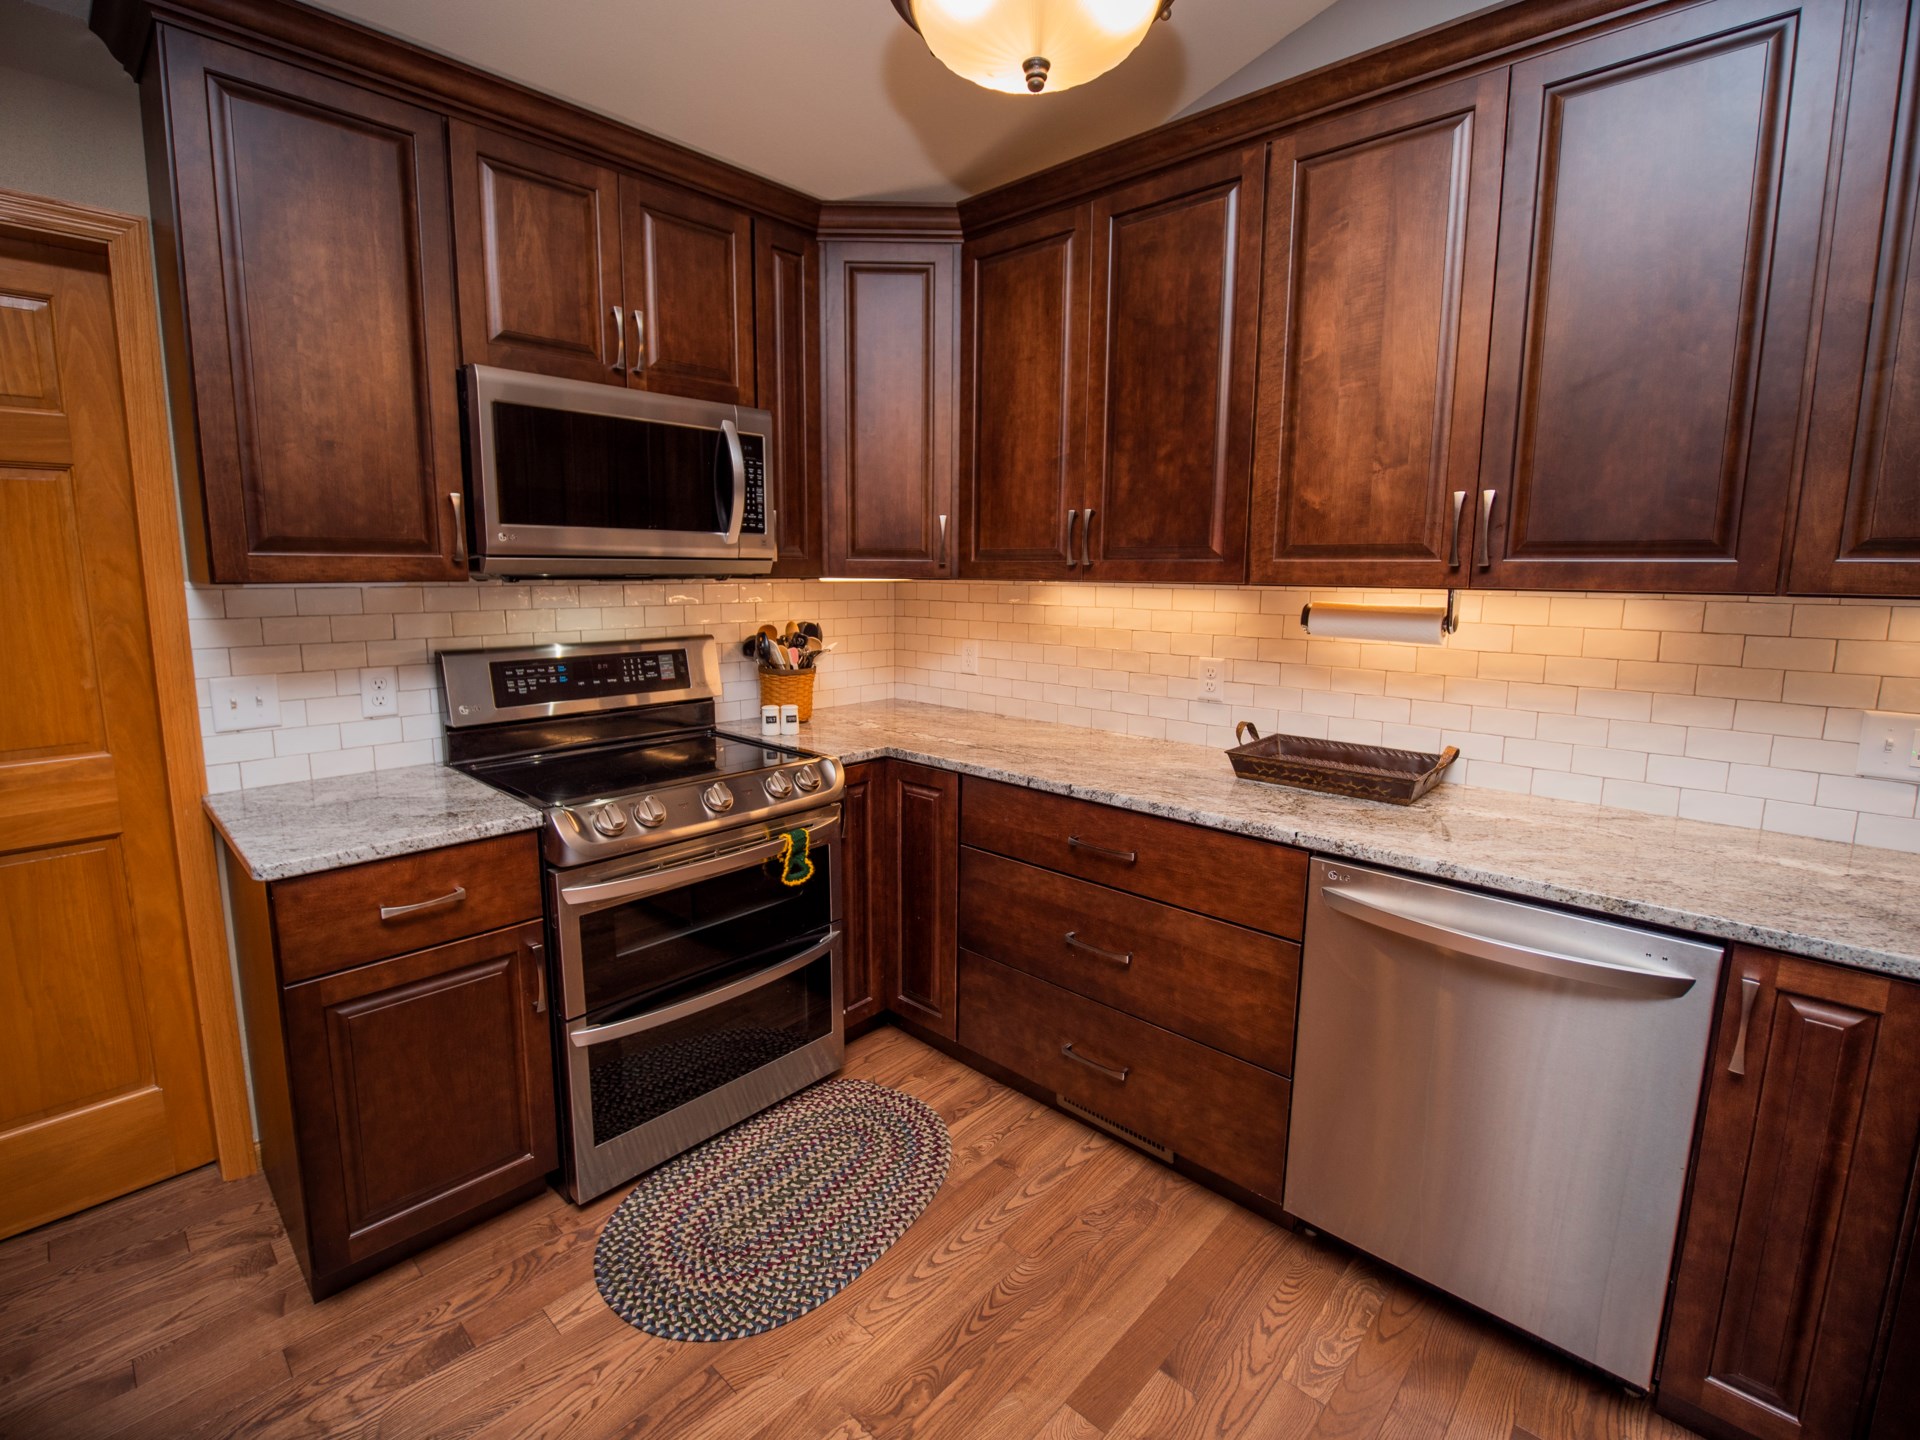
[1657,948,1920,1440]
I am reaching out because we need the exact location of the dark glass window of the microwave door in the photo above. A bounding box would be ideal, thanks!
[493,401,733,534]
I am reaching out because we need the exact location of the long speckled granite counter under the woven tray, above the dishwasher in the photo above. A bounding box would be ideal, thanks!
[801,703,1920,979]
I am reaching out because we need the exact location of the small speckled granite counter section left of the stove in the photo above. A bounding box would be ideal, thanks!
[205,764,540,879]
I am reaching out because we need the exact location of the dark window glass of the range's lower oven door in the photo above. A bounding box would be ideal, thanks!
[588,954,833,1144]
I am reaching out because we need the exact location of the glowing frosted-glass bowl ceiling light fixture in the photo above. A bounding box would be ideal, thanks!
[893,0,1173,94]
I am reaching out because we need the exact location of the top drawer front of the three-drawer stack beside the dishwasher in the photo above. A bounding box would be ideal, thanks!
[960,778,1308,941]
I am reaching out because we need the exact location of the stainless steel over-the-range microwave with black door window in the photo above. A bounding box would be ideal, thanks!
[461,365,776,576]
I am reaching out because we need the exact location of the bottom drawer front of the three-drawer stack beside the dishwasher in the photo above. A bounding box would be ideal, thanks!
[960,950,1290,1204]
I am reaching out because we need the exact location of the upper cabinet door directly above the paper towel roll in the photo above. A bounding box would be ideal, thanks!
[1250,71,1507,586]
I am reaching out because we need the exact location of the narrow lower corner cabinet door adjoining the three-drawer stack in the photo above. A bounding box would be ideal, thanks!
[885,760,960,1041]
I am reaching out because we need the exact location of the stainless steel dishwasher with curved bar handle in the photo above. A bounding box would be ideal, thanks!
[1286,856,1724,1388]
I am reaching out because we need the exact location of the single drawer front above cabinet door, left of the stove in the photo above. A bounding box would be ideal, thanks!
[271,831,540,985]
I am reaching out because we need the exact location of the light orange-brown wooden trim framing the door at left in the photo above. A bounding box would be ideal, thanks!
[0,190,259,1181]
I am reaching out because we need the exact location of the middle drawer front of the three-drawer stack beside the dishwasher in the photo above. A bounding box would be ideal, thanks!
[960,849,1300,1075]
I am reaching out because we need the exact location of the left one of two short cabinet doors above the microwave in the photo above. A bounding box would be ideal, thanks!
[447,121,626,384]
